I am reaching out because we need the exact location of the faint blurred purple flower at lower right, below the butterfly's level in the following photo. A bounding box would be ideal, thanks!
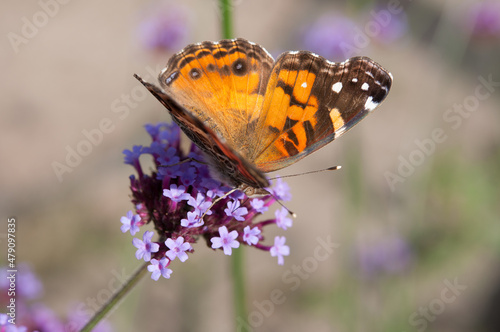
[357,235,413,278]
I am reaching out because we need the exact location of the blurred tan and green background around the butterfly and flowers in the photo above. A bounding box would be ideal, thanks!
[0,0,500,332]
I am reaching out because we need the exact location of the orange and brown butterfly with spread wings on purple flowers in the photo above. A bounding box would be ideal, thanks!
[134,38,392,196]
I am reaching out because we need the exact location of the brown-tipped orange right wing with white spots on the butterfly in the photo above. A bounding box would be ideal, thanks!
[249,51,392,172]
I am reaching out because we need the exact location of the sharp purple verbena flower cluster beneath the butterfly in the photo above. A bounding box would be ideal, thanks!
[121,123,292,280]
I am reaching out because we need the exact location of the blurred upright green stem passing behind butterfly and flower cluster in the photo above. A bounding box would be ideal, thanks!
[219,0,247,321]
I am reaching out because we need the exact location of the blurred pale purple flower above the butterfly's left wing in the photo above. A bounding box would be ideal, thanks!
[139,3,189,52]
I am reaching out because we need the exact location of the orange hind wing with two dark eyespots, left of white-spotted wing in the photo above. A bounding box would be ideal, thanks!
[159,39,274,155]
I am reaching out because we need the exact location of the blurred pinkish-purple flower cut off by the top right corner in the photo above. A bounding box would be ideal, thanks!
[467,1,500,37]
